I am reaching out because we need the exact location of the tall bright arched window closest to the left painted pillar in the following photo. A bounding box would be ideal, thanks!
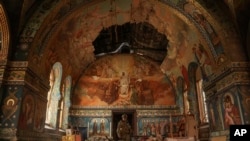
[45,62,62,128]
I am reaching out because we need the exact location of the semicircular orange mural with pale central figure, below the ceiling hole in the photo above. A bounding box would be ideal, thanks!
[73,54,176,106]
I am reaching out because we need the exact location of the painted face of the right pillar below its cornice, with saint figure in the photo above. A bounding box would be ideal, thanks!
[208,86,247,131]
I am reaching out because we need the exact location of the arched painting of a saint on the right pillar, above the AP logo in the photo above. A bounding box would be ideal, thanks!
[222,91,242,129]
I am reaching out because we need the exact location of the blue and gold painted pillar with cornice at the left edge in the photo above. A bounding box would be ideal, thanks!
[0,61,48,140]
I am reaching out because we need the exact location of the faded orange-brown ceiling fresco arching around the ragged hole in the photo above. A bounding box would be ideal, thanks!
[44,0,217,83]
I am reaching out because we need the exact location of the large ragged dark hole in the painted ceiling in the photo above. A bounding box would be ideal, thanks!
[93,22,168,62]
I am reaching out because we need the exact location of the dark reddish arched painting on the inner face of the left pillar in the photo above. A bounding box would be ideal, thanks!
[19,94,36,130]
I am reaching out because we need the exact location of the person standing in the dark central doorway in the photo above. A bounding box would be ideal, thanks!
[116,114,131,141]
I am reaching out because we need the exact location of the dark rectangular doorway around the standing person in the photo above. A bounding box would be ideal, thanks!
[112,110,136,140]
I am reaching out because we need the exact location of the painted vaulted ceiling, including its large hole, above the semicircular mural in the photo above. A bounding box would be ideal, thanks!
[0,0,250,86]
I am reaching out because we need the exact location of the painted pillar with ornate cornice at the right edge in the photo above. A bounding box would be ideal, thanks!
[204,62,250,138]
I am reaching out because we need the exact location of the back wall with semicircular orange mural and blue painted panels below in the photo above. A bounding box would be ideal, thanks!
[70,54,183,137]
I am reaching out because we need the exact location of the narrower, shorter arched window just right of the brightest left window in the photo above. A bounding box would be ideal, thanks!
[60,76,72,129]
